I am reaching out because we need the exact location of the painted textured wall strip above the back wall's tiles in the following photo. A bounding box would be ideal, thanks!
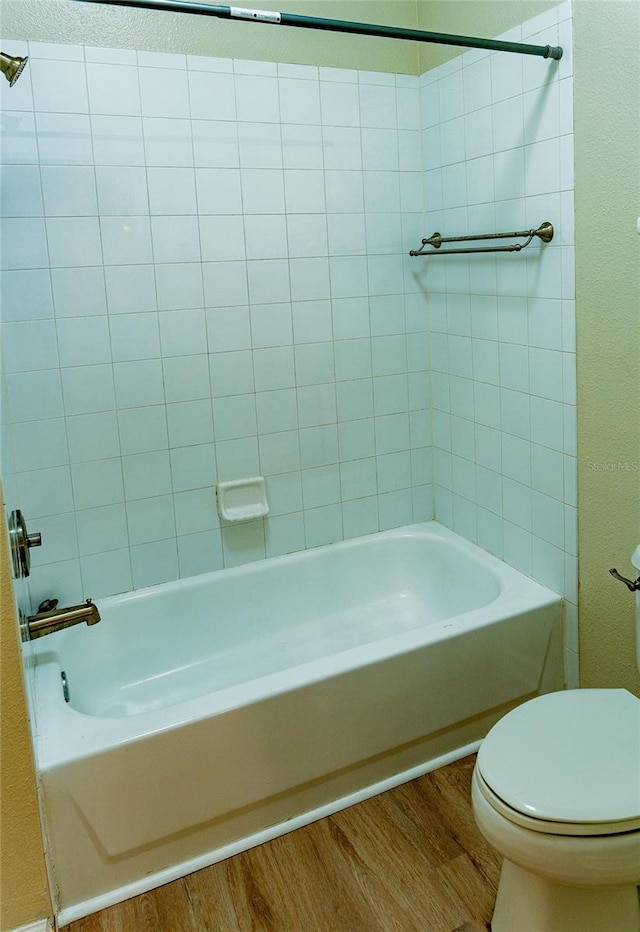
[0,0,422,74]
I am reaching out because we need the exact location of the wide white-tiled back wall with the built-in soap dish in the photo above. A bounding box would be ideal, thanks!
[0,43,433,604]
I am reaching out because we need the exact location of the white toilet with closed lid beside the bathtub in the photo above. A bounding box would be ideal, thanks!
[472,548,640,932]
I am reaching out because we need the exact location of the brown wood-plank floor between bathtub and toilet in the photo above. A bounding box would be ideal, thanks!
[69,757,500,932]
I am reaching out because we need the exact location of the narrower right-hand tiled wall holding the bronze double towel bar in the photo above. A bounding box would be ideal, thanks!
[417,5,578,684]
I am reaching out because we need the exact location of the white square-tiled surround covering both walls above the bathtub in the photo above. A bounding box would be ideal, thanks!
[1,5,576,676]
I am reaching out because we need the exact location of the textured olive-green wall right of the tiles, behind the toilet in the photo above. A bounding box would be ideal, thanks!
[574,0,640,696]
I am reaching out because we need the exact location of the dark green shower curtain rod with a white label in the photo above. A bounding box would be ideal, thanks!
[78,0,562,60]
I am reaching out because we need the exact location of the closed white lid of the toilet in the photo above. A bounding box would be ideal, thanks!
[477,689,640,824]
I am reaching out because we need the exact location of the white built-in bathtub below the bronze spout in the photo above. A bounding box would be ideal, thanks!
[29,523,563,925]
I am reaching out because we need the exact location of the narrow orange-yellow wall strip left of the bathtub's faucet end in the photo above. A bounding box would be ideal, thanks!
[0,480,51,932]
